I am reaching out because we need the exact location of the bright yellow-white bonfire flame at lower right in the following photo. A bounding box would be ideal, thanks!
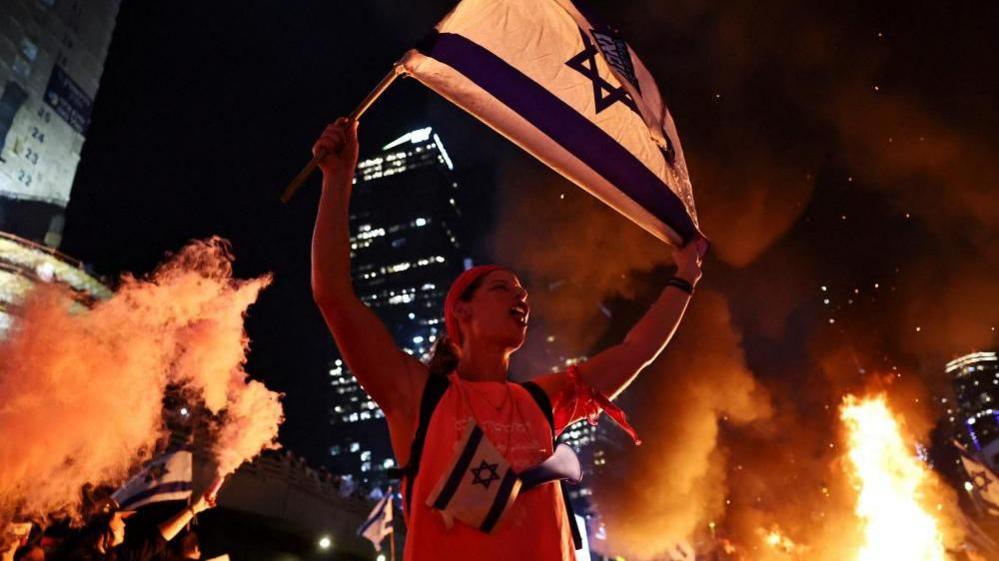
[840,395,948,561]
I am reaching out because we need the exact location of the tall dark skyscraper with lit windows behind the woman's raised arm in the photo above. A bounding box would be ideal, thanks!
[329,127,466,483]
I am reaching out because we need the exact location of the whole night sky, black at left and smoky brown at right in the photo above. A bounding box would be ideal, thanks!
[61,0,999,508]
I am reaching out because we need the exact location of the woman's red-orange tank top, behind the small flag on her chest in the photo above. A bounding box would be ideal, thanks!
[405,374,575,561]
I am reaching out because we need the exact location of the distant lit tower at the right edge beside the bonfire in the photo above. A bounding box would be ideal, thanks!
[946,352,999,468]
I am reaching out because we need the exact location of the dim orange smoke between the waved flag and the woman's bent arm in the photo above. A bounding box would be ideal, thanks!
[493,161,670,369]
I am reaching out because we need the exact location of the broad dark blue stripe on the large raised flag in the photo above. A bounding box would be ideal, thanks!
[417,32,696,243]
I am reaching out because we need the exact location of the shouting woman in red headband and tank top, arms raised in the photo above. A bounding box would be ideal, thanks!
[312,118,707,561]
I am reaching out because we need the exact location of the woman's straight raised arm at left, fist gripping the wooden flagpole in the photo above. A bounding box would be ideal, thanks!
[312,118,427,420]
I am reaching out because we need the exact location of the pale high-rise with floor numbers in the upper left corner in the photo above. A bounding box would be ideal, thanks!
[0,0,119,247]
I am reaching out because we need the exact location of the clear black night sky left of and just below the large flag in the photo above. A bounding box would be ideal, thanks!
[61,1,512,462]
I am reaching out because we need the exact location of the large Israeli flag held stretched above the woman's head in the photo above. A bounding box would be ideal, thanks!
[400,0,699,245]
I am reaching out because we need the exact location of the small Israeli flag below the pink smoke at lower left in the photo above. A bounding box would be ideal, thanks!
[111,450,193,510]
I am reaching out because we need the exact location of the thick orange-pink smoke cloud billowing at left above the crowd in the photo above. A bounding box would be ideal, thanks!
[0,238,282,528]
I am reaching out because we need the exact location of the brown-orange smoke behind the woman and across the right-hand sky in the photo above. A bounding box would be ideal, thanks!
[482,0,999,561]
